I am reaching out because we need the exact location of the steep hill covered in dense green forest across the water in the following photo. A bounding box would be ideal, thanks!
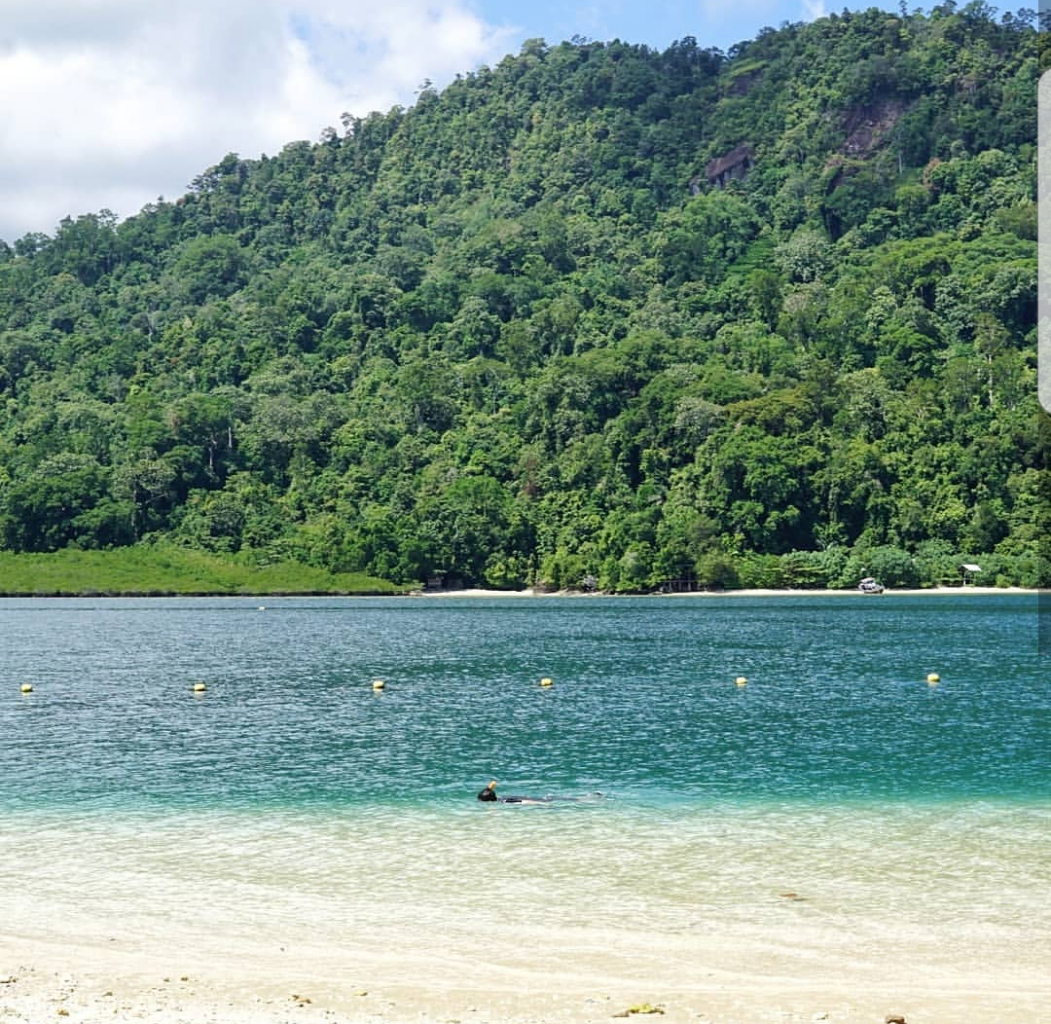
[0,2,1051,591]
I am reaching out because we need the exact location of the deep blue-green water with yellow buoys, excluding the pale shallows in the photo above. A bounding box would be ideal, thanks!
[0,595,1051,811]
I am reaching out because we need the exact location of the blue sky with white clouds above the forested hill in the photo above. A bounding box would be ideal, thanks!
[0,0,898,242]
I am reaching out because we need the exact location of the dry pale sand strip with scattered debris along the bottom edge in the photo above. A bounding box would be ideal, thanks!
[0,922,1051,1024]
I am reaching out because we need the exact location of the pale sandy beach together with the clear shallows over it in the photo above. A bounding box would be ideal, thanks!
[0,807,1051,1024]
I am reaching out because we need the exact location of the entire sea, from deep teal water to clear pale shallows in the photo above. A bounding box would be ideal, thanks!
[0,594,1051,1000]
